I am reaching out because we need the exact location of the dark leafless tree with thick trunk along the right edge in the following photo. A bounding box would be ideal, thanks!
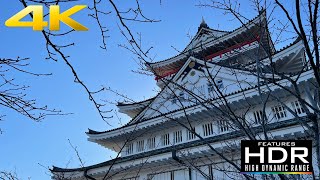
[194,0,320,177]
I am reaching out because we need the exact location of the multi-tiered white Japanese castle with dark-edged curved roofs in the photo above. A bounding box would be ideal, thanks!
[51,11,315,180]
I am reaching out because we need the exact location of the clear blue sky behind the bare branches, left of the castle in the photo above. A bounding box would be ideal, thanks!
[0,0,296,180]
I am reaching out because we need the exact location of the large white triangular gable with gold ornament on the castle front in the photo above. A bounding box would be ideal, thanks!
[134,57,257,122]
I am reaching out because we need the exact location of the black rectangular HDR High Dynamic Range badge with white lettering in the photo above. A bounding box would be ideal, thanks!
[241,140,312,174]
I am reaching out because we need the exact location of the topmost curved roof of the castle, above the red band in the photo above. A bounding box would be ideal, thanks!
[146,10,275,79]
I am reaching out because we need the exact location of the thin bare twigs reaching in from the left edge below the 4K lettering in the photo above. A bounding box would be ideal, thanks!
[0,57,64,131]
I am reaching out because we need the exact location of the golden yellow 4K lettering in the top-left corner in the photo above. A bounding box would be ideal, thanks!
[5,5,88,31]
